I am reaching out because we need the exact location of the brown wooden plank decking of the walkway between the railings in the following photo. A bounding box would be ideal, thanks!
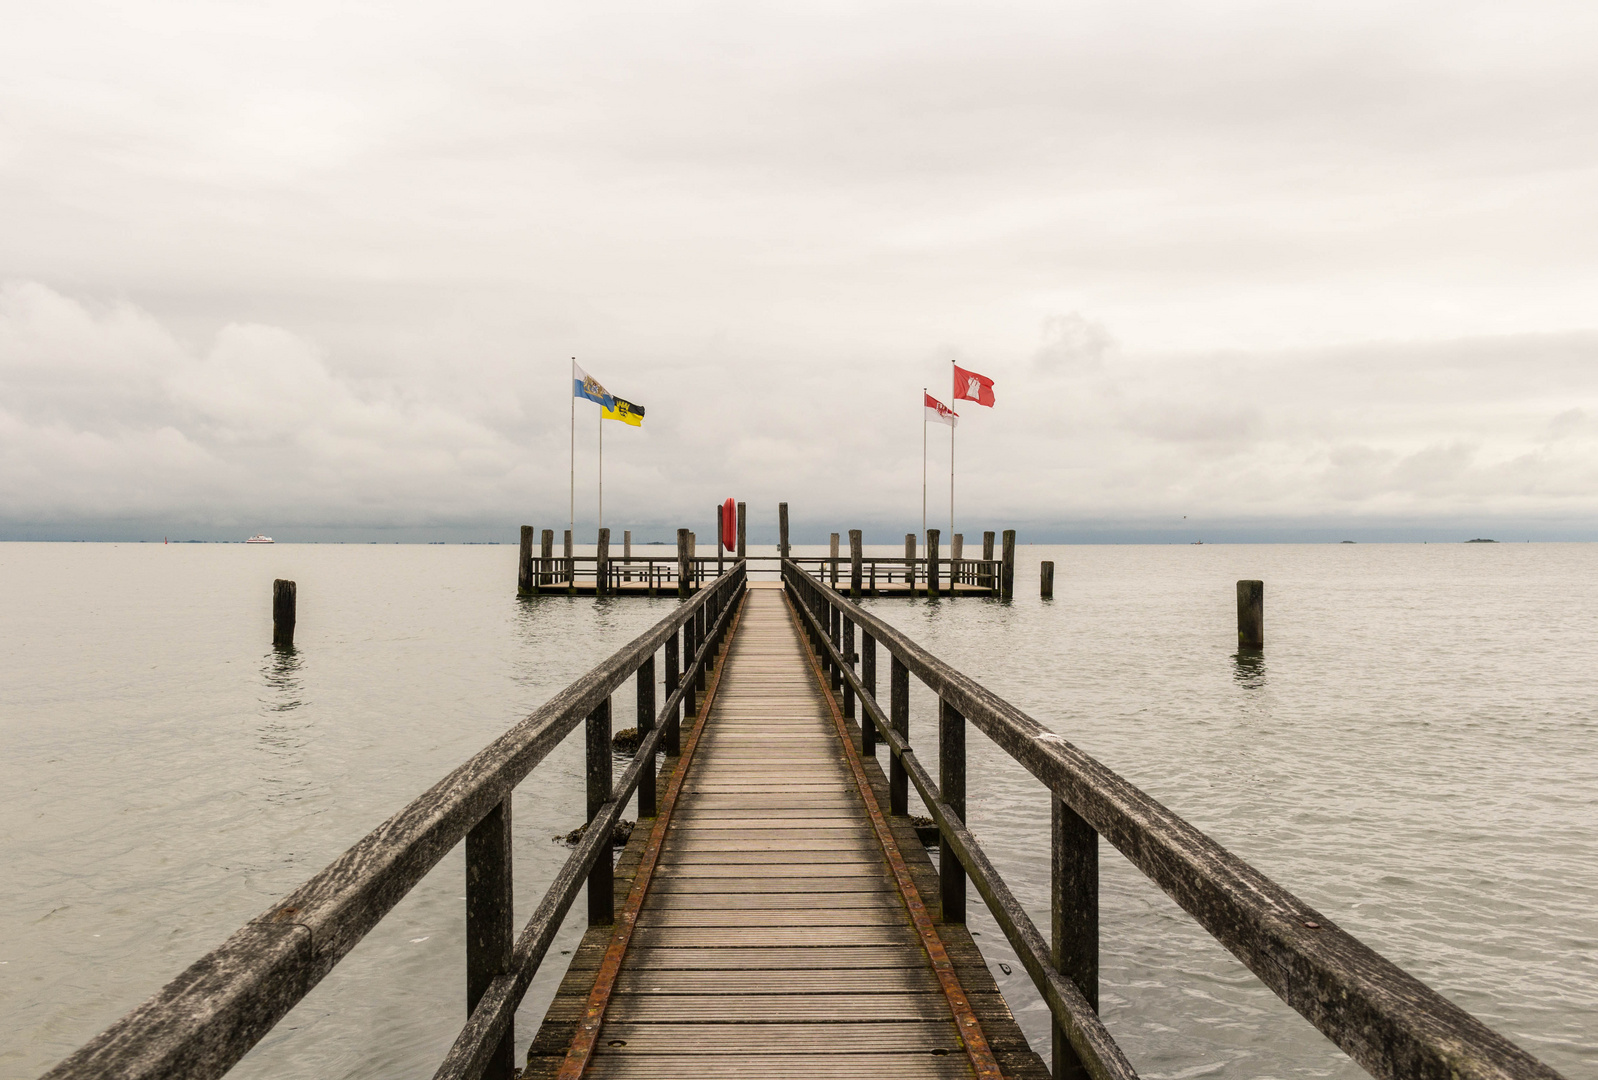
[526,588,1047,1078]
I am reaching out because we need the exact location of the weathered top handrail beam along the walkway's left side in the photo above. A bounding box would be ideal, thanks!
[45,562,745,1080]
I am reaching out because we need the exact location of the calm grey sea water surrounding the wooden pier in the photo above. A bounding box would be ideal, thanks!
[0,543,1598,1080]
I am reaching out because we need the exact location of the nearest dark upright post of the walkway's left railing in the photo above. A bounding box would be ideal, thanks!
[467,796,516,1080]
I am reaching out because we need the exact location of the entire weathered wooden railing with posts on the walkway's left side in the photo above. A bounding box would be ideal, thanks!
[45,562,746,1080]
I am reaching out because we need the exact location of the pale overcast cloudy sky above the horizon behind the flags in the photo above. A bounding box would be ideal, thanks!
[0,0,1598,538]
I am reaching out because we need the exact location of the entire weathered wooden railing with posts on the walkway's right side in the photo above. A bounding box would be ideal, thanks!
[783,559,1558,1080]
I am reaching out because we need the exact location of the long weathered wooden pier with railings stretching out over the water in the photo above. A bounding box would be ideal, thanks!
[46,533,1560,1080]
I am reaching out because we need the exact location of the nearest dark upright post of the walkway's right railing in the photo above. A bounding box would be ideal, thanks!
[1050,797,1098,1080]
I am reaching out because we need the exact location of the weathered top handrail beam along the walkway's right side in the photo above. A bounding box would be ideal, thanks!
[783,559,1560,1080]
